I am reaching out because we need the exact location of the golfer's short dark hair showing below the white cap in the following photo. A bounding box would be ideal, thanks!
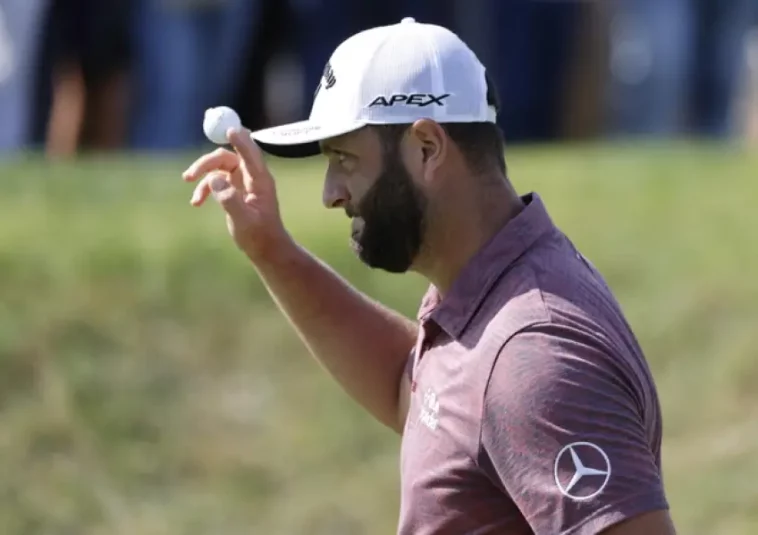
[374,72,506,174]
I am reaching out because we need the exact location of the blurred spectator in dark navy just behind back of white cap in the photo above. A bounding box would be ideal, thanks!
[454,0,585,143]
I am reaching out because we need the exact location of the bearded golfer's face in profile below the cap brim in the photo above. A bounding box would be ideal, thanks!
[325,131,427,273]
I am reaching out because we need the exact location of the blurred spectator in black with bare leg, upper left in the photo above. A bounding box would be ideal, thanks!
[34,0,131,156]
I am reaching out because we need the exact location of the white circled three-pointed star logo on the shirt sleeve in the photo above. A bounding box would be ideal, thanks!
[553,442,611,501]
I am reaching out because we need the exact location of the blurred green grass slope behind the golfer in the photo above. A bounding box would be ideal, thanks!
[0,140,758,535]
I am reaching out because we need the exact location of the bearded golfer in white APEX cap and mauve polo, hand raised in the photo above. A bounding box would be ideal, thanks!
[184,19,675,535]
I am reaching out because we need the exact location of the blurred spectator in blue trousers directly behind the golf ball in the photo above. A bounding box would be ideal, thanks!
[131,0,262,150]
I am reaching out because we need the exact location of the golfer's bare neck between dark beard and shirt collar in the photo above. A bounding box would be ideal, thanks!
[416,180,524,296]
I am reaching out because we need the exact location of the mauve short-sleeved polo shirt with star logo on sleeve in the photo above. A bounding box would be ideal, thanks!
[398,193,668,535]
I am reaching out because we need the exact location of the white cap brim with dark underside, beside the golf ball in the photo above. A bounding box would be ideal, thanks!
[250,121,366,158]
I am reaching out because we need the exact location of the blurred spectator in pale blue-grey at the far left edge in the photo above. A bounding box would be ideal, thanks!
[0,0,47,153]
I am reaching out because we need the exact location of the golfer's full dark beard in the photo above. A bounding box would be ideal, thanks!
[351,153,426,273]
